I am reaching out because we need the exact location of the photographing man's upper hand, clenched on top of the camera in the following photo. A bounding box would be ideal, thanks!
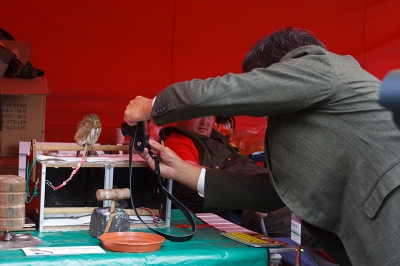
[124,96,153,126]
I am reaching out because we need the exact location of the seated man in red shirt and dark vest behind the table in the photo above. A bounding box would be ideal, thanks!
[160,116,318,248]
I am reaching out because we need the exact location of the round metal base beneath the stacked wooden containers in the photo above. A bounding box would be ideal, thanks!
[0,230,42,250]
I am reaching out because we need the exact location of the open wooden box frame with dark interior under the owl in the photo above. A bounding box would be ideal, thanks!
[26,140,172,231]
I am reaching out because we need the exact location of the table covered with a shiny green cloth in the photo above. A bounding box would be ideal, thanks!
[0,209,269,266]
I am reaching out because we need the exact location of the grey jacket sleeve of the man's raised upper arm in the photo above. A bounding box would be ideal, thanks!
[152,46,333,125]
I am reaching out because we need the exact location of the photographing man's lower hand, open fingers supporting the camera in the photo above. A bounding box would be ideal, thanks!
[139,140,202,191]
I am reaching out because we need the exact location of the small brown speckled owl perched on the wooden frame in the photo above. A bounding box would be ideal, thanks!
[75,114,101,157]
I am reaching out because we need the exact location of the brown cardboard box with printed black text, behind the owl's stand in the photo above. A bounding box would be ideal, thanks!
[0,41,50,157]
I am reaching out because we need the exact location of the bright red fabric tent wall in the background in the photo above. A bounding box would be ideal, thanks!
[0,0,400,143]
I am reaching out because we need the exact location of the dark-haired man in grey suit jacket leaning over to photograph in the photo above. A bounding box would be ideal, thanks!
[125,28,400,265]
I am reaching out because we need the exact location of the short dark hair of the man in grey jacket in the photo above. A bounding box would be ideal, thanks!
[242,27,326,72]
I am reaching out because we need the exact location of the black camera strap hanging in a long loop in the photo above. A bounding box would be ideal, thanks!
[129,137,197,242]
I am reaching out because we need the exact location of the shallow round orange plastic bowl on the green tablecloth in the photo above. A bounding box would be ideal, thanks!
[100,232,165,252]
